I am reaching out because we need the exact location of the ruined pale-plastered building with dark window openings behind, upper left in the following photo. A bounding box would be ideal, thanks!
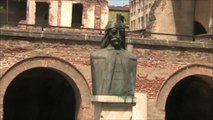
[0,0,108,29]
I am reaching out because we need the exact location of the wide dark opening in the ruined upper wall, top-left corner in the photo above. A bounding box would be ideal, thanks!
[0,0,27,25]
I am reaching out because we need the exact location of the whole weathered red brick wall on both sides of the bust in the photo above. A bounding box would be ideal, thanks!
[0,36,213,119]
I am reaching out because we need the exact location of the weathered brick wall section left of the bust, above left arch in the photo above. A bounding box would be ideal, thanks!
[0,38,94,87]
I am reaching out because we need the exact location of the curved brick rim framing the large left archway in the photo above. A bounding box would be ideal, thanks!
[0,56,93,119]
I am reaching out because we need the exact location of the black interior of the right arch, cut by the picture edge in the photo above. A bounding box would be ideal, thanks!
[166,76,213,120]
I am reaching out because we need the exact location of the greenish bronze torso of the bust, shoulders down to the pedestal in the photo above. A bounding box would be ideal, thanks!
[91,48,137,95]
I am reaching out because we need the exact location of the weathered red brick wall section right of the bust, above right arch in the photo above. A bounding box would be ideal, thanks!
[136,47,213,98]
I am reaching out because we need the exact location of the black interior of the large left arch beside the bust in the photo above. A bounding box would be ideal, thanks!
[3,68,76,120]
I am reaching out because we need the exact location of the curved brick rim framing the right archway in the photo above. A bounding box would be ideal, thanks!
[156,65,213,110]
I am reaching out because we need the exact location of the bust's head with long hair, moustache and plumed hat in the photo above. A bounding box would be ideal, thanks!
[101,14,126,50]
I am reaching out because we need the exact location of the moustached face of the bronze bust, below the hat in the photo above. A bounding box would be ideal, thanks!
[109,28,124,49]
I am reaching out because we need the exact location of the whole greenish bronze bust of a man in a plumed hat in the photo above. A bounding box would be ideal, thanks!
[91,14,137,96]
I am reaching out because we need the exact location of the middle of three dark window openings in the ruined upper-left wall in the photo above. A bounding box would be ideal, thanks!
[35,2,49,27]
